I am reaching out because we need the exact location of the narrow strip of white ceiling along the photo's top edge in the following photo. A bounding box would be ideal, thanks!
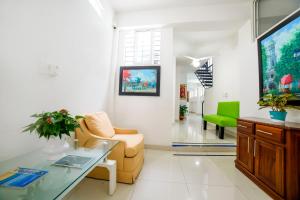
[110,0,250,13]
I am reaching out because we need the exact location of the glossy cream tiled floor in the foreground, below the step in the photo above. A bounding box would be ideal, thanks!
[67,150,271,200]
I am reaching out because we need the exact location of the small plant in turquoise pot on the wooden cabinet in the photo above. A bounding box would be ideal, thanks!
[257,93,300,121]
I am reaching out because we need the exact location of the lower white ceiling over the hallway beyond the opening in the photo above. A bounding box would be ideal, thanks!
[173,19,246,59]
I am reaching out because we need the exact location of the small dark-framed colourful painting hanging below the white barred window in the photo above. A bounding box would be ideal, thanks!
[119,66,160,96]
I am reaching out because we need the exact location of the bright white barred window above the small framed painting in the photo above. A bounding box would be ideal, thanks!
[124,30,161,65]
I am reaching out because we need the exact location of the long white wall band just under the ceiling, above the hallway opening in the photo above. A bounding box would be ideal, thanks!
[117,1,251,27]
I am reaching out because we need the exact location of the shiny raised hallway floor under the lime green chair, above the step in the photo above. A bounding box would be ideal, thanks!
[172,114,236,144]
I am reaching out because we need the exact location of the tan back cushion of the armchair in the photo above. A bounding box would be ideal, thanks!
[84,112,115,138]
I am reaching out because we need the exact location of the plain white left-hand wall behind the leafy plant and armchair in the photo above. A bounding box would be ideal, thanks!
[0,0,113,160]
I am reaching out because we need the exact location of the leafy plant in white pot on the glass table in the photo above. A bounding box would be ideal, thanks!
[23,109,83,159]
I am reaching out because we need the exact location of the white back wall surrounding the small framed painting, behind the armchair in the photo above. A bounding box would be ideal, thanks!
[114,28,175,146]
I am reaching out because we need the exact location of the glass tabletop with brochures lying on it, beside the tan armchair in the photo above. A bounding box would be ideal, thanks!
[0,140,118,200]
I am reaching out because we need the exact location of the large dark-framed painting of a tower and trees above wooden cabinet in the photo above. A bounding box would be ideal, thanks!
[257,9,300,105]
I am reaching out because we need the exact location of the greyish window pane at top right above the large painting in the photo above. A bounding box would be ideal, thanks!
[253,0,300,37]
